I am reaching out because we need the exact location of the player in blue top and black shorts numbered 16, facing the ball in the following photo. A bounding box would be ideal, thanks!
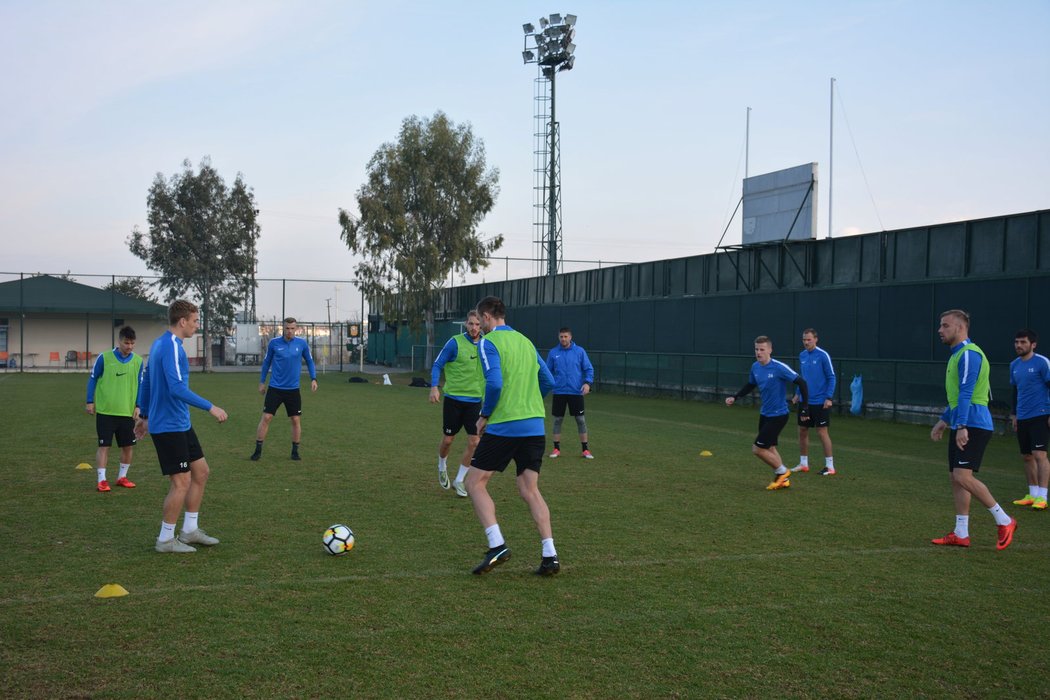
[134,299,227,553]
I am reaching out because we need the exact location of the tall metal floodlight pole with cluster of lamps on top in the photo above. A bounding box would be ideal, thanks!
[522,14,576,277]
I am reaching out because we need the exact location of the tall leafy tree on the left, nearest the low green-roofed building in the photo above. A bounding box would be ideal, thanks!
[128,157,259,369]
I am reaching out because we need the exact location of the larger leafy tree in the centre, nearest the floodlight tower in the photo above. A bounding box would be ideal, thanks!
[339,111,503,346]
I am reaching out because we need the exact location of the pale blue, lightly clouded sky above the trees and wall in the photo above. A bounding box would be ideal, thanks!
[0,0,1050,320]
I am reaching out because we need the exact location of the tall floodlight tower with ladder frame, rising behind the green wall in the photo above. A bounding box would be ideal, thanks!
[522,14,576,276]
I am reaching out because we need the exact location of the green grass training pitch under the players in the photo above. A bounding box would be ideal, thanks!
[0,375,1050,698]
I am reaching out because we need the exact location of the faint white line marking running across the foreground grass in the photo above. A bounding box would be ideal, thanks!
[0,544,1050,607]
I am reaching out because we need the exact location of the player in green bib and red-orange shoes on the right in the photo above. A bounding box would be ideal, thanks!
[929,309,1017,550]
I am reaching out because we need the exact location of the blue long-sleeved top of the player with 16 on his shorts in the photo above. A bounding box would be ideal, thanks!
[139,331,211,432]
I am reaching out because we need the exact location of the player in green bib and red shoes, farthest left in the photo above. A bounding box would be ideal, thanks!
[86,325,142,493]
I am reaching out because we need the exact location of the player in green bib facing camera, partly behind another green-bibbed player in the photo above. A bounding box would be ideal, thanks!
[431,310,485,499]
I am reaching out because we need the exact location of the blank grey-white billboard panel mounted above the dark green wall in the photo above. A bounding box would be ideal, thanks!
[742,163,817,246]
